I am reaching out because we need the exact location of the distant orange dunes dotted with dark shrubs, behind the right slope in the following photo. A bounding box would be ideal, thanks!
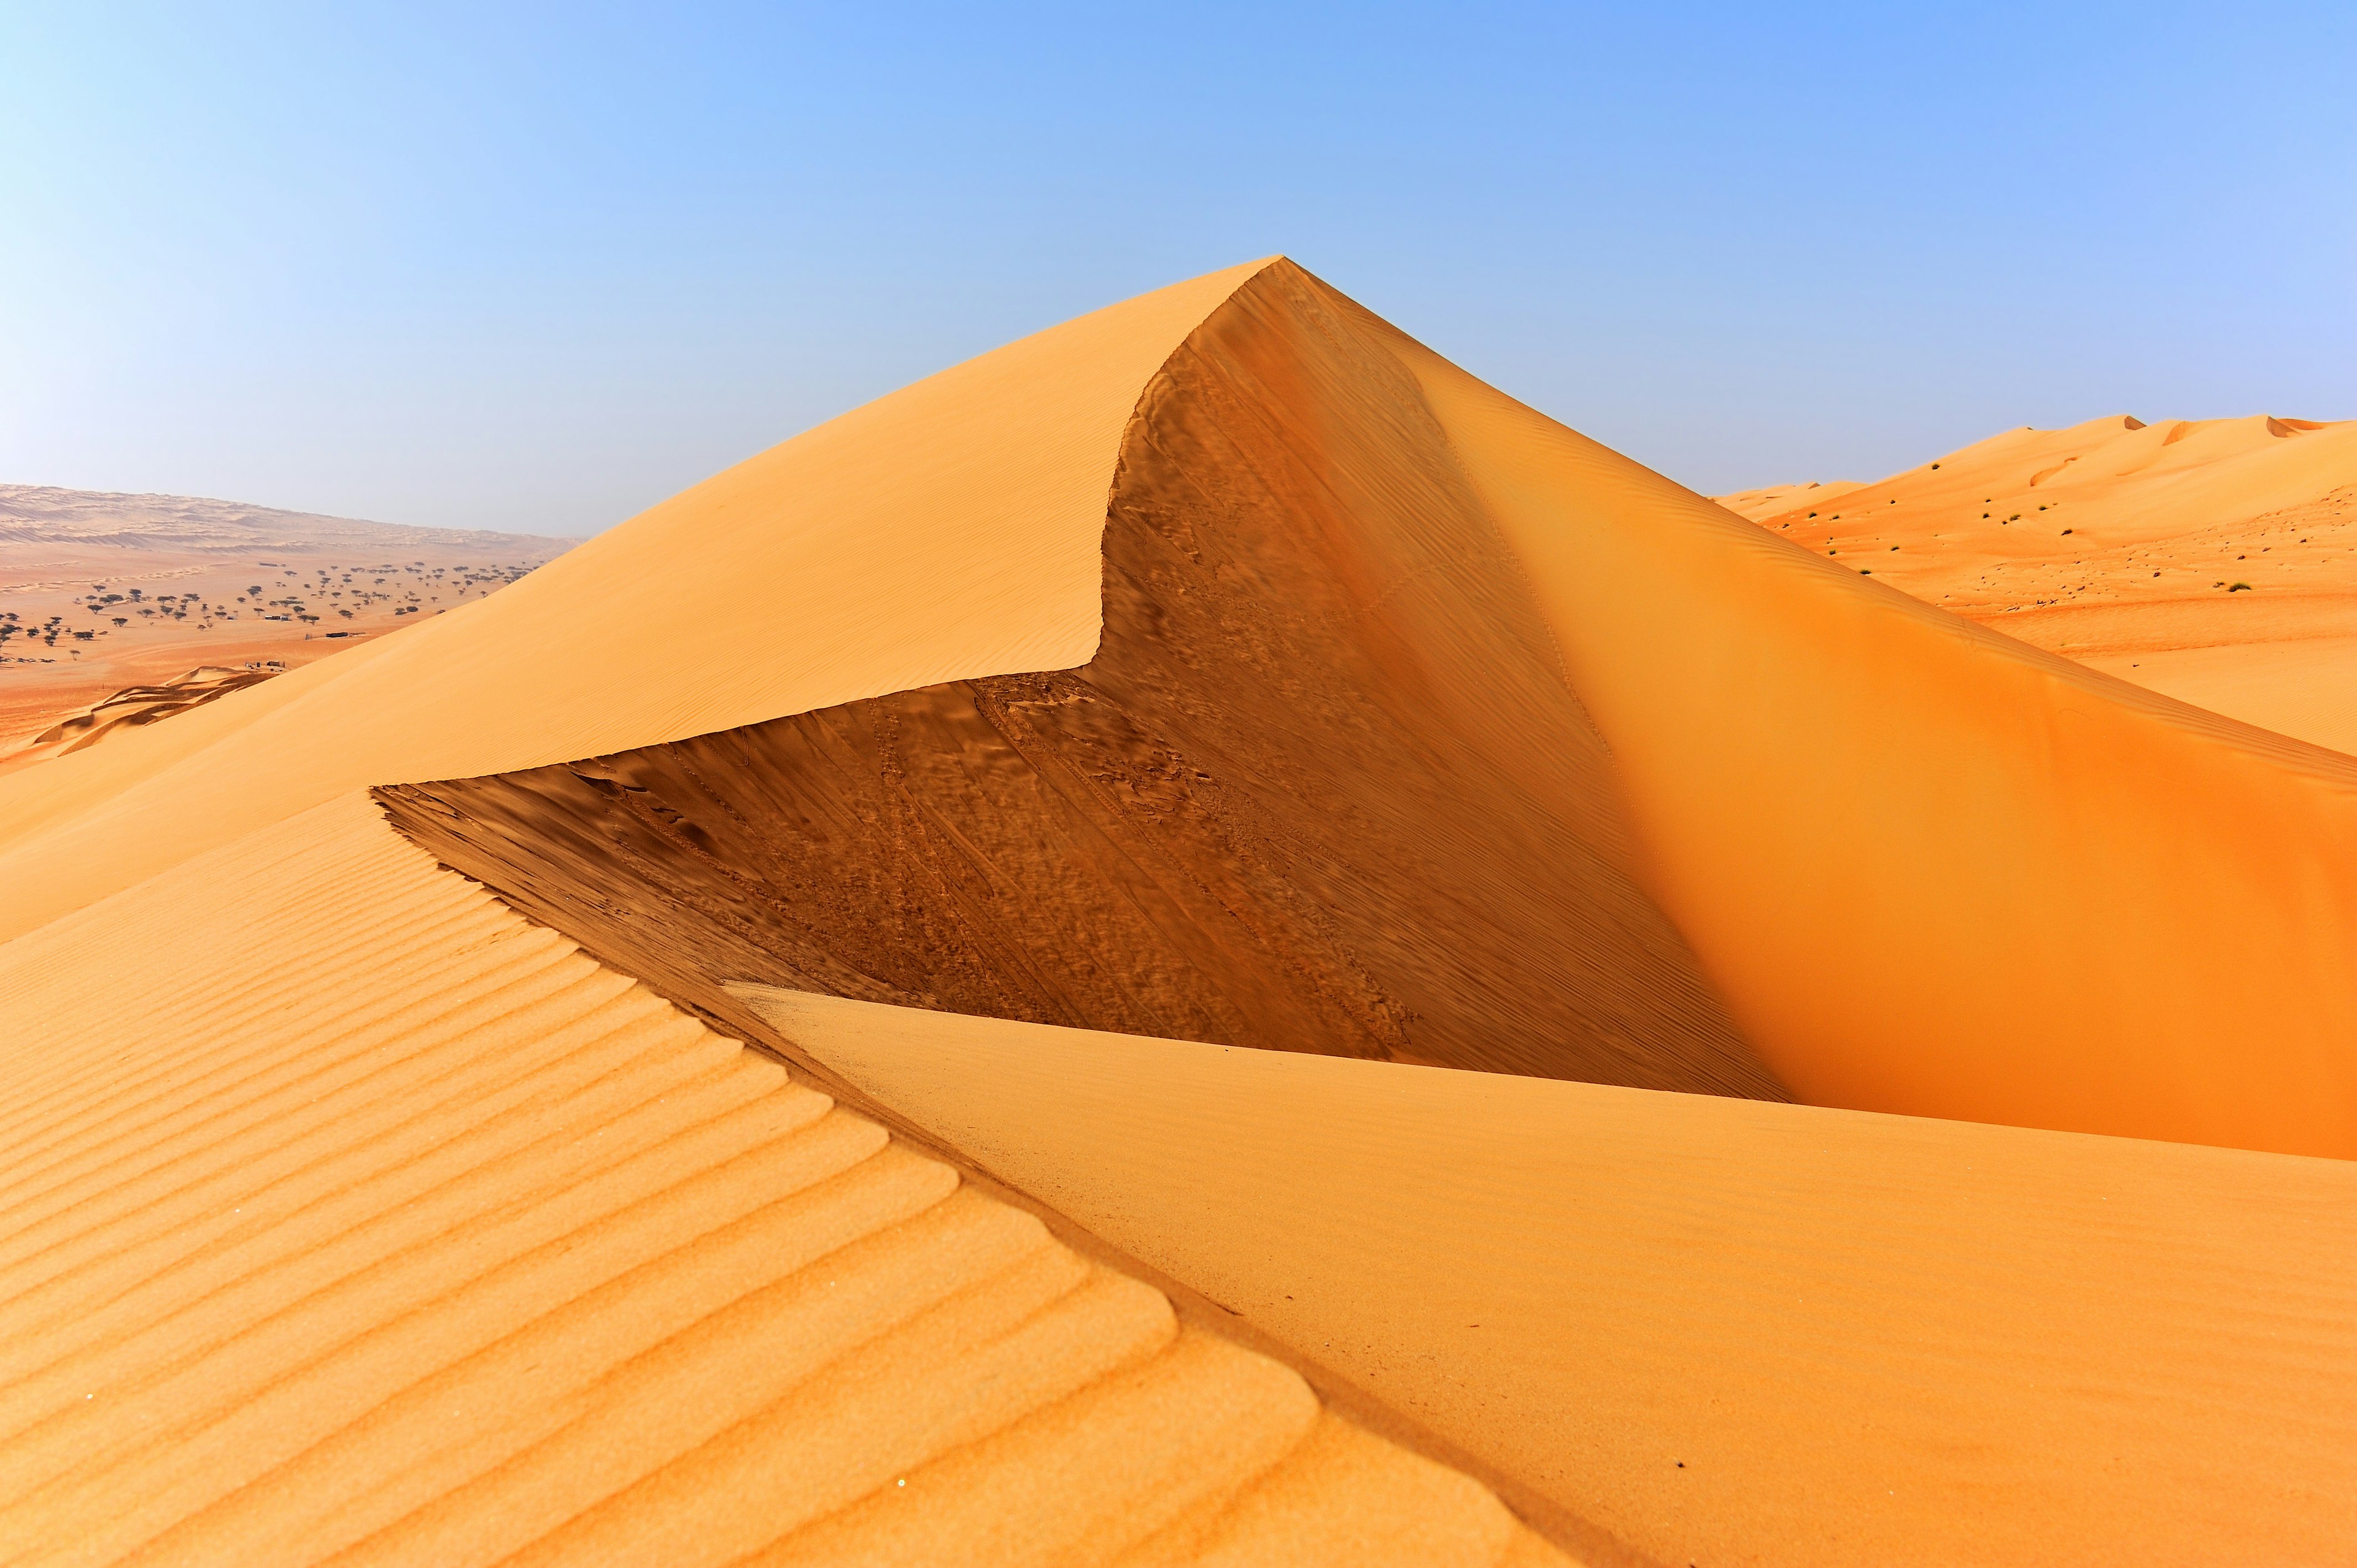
[1718,415,2357,752]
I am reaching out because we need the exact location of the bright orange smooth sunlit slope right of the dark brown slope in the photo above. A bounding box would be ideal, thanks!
[1369,319,2357,1156]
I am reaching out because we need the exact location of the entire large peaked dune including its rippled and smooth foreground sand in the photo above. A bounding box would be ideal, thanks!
[0,260,2357,1568]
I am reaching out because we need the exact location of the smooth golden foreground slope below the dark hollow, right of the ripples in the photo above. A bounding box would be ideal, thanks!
[740,988,2357,1566]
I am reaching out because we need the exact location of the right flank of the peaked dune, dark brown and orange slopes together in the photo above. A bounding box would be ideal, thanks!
[387,264,2357,1156]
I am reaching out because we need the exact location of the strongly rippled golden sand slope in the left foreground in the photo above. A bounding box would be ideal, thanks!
[0,797,1565,1566]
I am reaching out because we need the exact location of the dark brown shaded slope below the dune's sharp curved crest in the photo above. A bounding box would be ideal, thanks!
[379,261,1782,1097]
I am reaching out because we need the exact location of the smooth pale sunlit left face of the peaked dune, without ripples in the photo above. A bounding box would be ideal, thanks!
[0,261,1261,938]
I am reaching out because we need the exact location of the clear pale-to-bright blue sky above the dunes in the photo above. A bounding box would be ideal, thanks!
[0,0,2357,533]
